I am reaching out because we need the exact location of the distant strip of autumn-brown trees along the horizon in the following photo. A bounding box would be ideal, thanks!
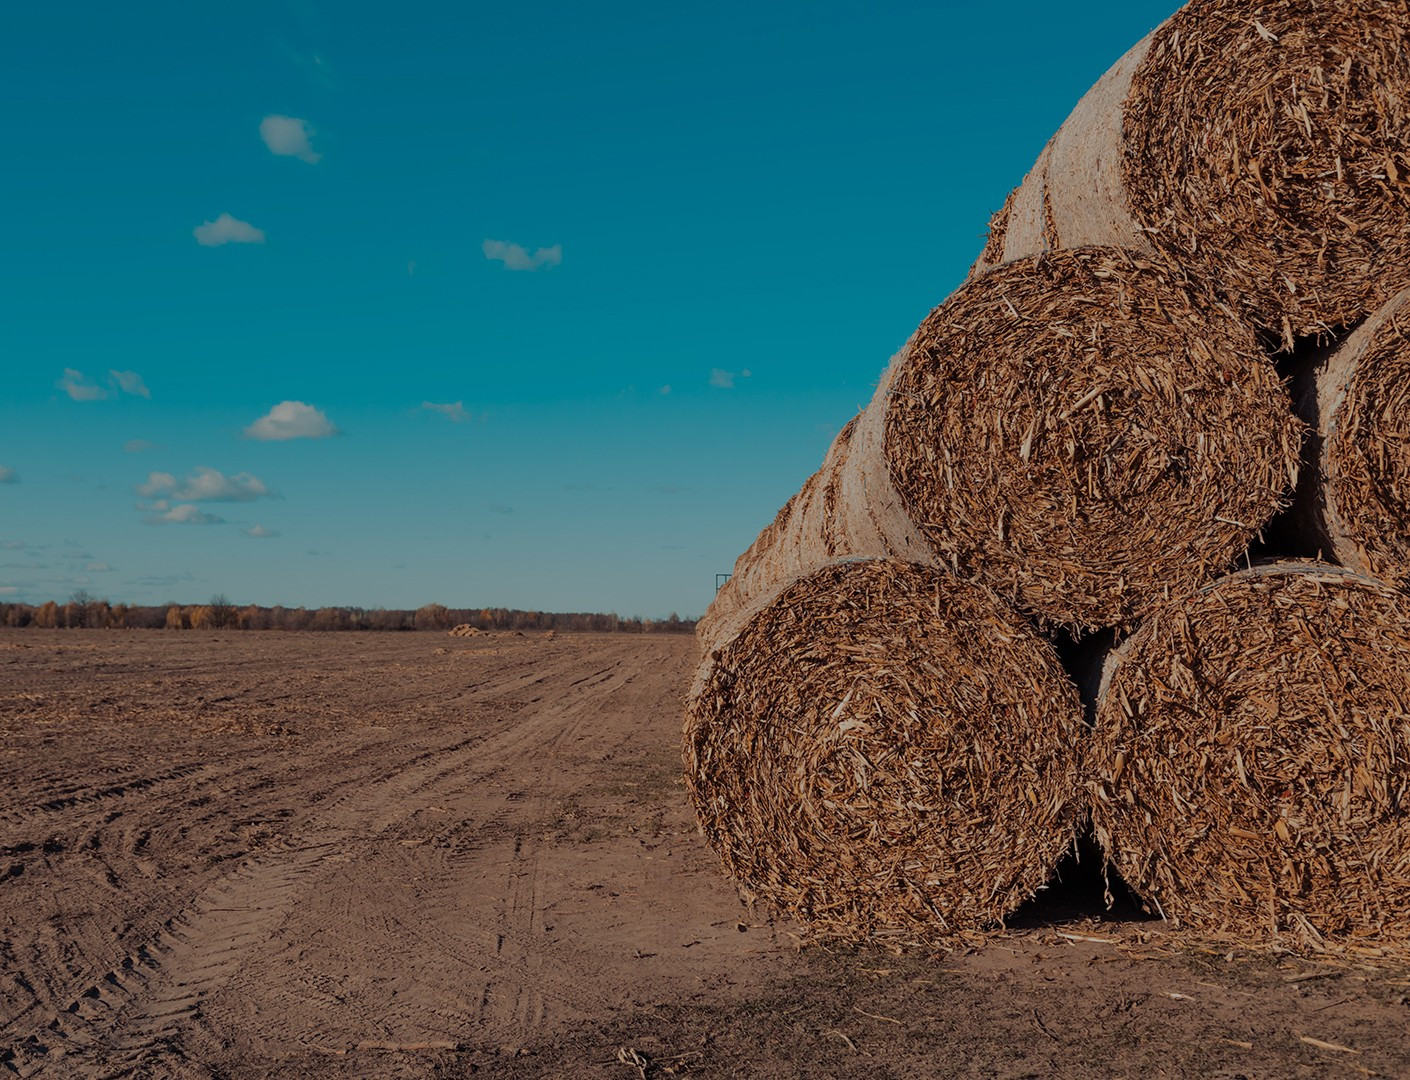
[0,594,695,633]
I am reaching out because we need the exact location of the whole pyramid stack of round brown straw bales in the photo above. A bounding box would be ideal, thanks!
[685,0,1410,949]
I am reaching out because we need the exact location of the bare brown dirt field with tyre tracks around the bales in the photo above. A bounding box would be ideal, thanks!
[0,630,1410,1080]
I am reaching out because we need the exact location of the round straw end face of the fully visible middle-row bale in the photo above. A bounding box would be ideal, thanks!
[885,248,1303,630]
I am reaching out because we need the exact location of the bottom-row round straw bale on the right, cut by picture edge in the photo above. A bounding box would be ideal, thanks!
[1089,563,1410,950]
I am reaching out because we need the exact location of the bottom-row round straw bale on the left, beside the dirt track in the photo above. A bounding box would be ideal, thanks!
[684,560,1084,943]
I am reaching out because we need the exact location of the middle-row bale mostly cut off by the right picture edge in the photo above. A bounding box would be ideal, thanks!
[1299,289,1410,585]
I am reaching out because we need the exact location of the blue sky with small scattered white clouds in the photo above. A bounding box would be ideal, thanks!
[0,0,1172,616]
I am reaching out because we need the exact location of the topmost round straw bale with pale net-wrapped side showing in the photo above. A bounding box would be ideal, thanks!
[977,0,1410,348]
